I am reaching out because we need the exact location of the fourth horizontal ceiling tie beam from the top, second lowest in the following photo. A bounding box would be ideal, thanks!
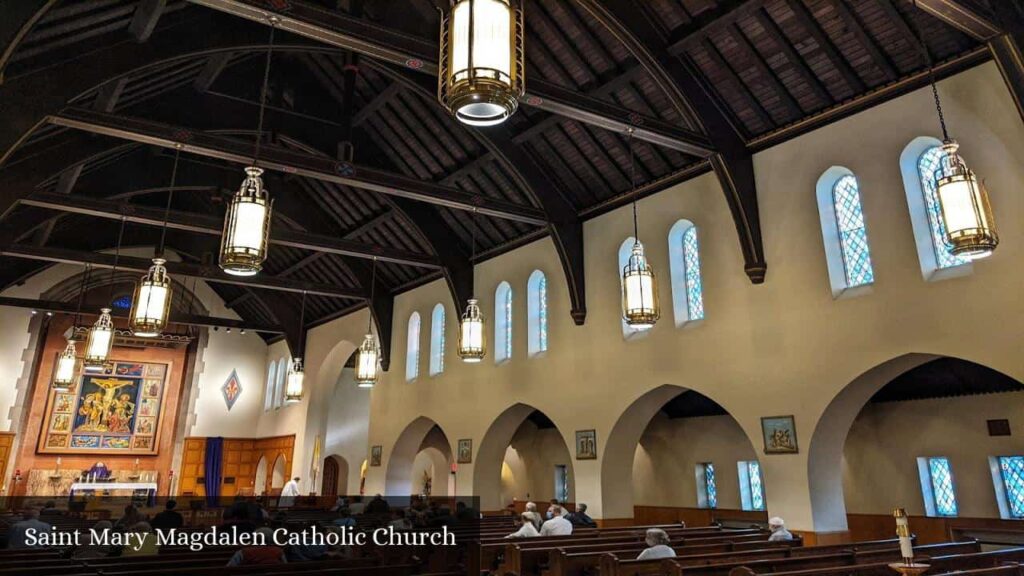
[0,244,366,300]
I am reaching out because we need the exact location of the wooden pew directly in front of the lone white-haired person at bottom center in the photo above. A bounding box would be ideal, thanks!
[498,530,784,575]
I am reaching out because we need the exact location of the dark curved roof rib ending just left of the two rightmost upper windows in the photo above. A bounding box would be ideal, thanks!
[579,0,768,284]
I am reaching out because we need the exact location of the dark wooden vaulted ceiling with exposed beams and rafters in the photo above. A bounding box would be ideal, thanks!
[0,0,1007,362]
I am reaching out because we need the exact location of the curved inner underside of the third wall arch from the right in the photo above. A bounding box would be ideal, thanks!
[473,403,574,510]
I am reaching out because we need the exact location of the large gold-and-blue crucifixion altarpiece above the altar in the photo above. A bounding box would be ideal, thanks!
[39,361,169,454]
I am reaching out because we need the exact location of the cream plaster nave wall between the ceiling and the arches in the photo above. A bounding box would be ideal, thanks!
[356,64,1024,530]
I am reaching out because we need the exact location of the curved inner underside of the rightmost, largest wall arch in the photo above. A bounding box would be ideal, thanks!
[807,353,1019,532]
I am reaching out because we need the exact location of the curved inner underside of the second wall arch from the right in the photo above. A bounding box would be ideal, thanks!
[600,384,756,520]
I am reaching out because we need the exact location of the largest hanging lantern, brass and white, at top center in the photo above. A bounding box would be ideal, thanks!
[437,0,525,126]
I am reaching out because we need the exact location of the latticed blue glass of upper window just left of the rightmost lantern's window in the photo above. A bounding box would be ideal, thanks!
[833,174,874,287]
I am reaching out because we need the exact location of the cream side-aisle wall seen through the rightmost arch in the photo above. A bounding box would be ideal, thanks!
[839,392,1024,518]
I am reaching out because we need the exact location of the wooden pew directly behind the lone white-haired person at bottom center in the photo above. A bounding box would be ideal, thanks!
[600,541,981,576]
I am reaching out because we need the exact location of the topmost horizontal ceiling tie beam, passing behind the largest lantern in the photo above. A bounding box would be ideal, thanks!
[189,0,711,157]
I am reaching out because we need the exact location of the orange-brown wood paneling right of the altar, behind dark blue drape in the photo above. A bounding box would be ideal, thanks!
[177,435,295,497]
